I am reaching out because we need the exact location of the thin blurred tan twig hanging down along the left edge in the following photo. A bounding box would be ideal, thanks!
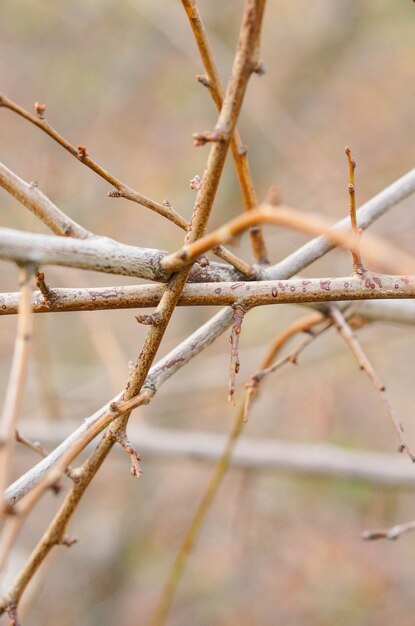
[0,266,33,509]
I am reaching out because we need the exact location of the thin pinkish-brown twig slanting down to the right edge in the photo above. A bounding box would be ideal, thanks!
[330,306,415,462]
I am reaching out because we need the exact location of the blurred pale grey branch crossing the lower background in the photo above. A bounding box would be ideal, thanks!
[17,423,415,489]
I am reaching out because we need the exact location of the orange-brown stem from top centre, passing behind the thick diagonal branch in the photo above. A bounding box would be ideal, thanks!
[182,0,269,264]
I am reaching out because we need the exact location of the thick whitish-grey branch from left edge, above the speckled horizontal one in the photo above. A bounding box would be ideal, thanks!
[0,228,243,282]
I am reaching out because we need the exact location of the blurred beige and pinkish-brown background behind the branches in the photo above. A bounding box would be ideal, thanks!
[0,0,415,626]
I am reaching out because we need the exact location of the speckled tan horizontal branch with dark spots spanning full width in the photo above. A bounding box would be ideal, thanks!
[0,272,415,315]
